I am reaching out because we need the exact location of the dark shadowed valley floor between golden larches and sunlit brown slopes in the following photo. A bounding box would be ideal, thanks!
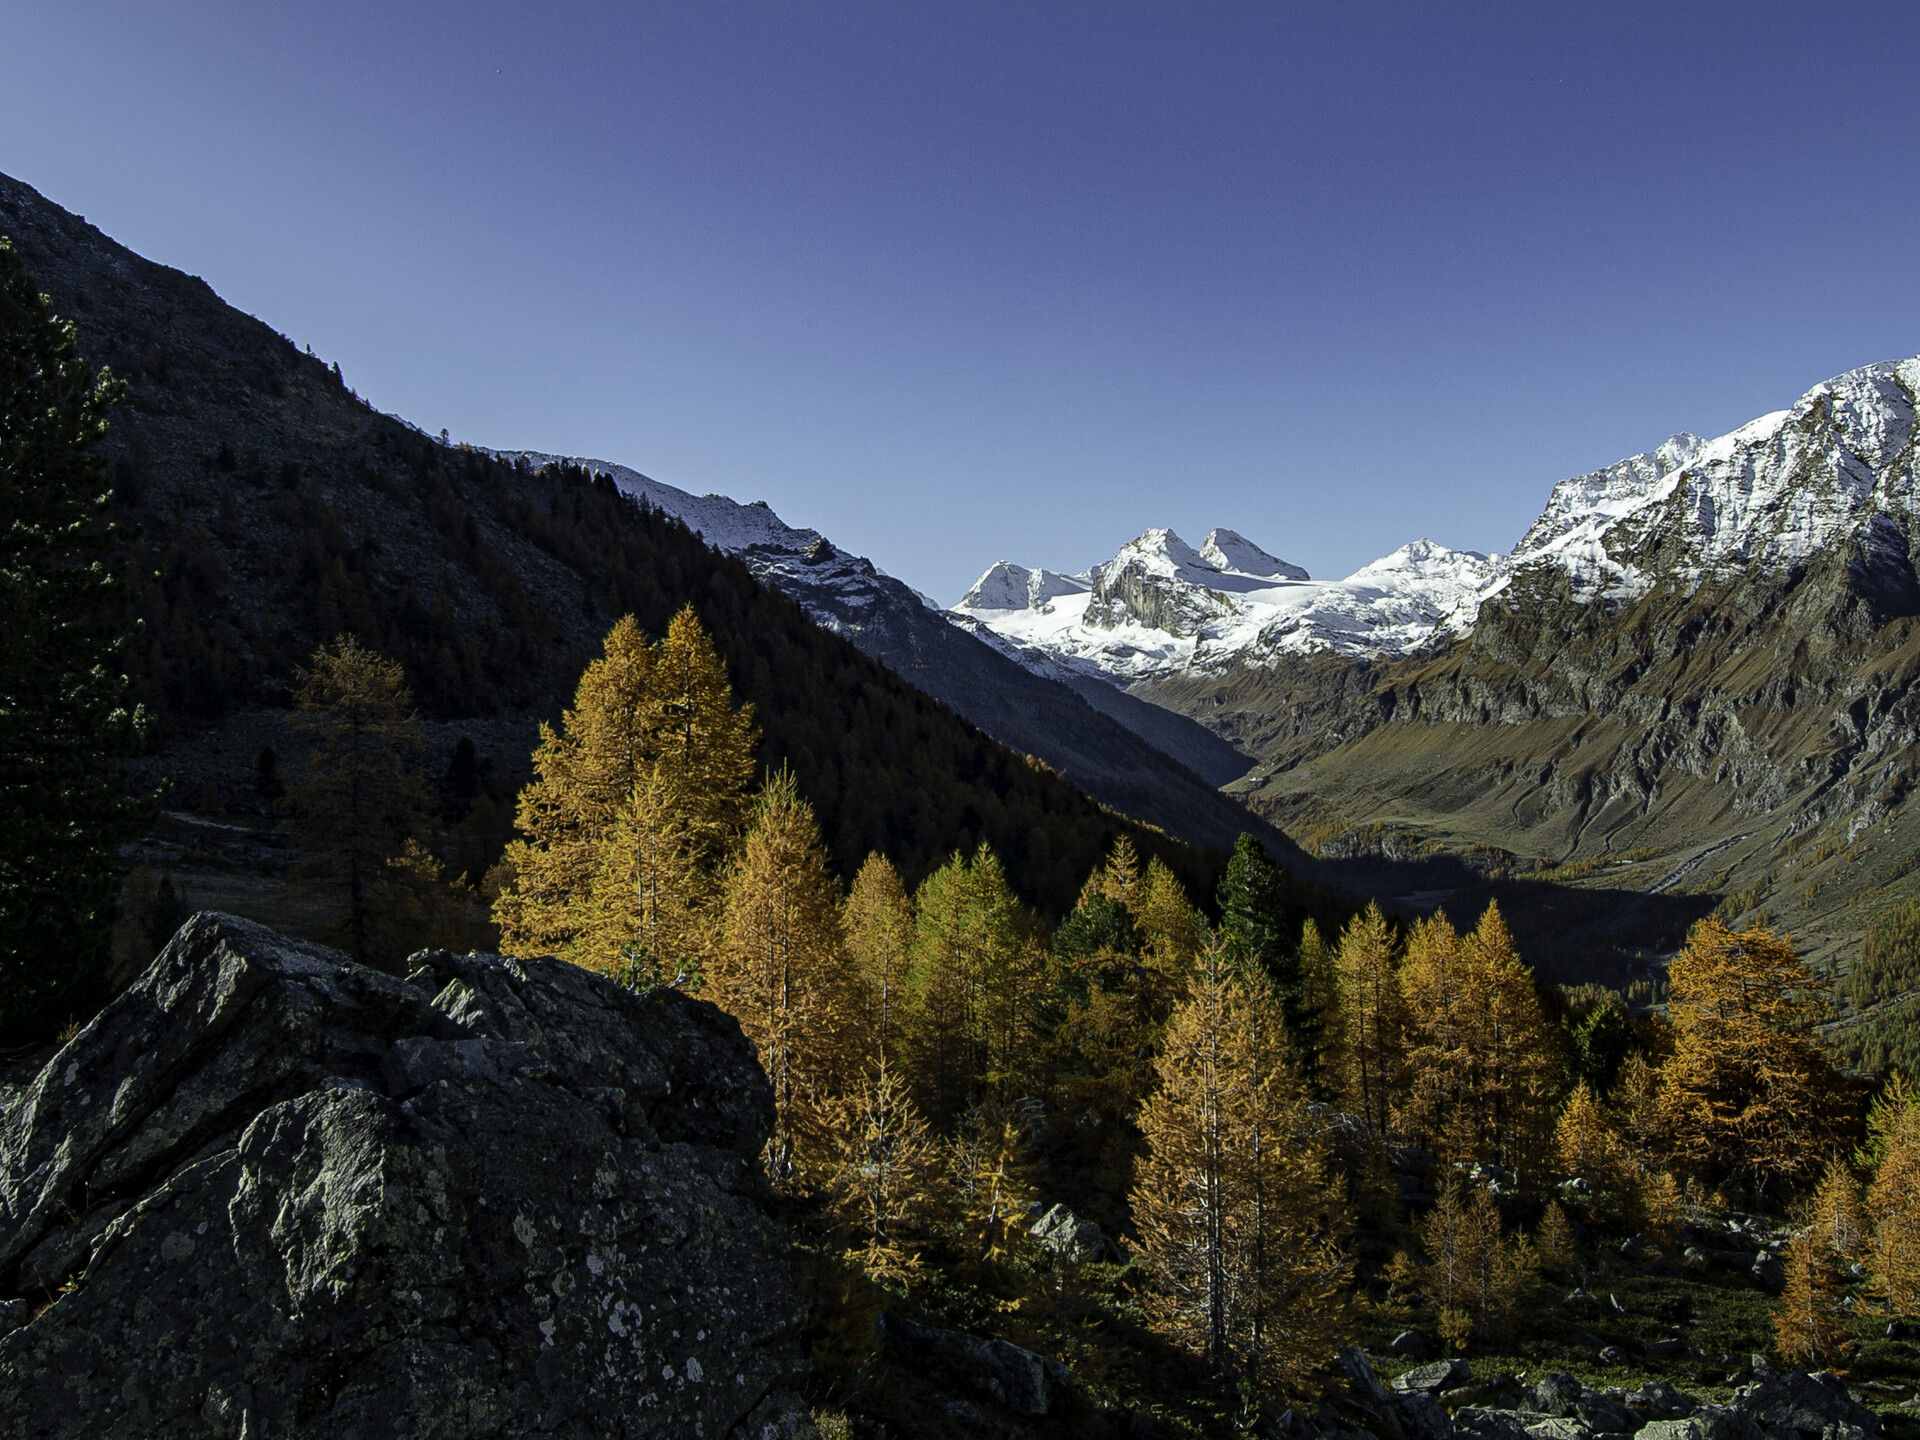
[1329,856,1720,989]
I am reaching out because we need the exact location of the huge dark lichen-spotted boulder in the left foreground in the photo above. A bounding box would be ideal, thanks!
[0,914,804,1440]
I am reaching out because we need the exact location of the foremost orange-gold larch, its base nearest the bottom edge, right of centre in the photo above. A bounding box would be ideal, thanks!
[1131,947,1350,1394]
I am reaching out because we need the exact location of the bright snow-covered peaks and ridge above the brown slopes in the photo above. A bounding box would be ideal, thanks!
[954,359,1920,685]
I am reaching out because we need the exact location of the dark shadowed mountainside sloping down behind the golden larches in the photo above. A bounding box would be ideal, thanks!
[0,166,1338,914]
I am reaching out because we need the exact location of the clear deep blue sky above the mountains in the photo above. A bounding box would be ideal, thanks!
[0,0,1920,603]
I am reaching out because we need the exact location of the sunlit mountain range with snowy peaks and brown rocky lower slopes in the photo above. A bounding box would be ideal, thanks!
[956,359,1920,990]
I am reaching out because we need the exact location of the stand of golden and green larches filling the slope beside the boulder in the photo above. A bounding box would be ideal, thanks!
[251,611,1889,1434]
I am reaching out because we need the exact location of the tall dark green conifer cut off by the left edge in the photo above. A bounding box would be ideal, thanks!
[0,238,156,1041]
